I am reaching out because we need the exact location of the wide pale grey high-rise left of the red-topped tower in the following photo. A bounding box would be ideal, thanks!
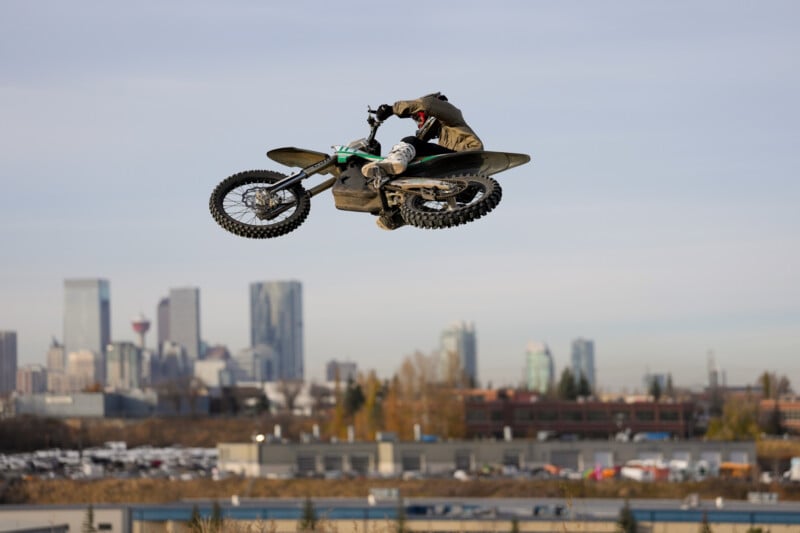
[64,279,111,374]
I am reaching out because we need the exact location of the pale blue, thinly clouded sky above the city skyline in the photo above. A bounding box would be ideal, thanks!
[0,0,800,389]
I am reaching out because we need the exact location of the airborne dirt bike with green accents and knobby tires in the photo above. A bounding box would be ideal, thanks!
[209,108,530,239]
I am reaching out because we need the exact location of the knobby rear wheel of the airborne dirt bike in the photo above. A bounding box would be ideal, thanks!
[400,174,503,229]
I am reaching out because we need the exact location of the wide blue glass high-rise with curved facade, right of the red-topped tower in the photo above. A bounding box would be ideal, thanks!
[250,281,304,380]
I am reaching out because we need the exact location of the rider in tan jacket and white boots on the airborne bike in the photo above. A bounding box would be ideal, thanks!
[361,92,483,230]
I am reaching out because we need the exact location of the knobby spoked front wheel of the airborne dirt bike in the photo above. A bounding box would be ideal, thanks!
[209,170,311,239]
